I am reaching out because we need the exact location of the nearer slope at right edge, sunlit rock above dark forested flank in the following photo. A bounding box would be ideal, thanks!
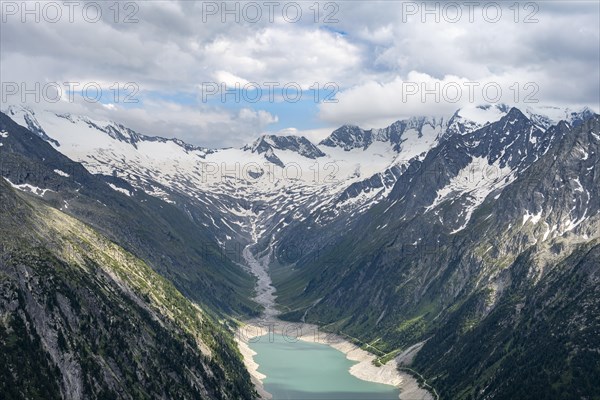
[416,116,600,399]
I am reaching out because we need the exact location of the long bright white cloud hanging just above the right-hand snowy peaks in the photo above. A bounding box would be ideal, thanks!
[319,69,598,128]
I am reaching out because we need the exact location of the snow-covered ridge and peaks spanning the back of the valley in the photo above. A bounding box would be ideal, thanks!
[6,105,593,247]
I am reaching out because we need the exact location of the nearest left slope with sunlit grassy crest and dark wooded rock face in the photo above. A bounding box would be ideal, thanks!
[0,178,254,399]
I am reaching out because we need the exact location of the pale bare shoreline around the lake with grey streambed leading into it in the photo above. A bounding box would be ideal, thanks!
[236,246,434,400]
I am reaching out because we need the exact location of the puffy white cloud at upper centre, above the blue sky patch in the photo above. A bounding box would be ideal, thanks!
[203,24,361,88]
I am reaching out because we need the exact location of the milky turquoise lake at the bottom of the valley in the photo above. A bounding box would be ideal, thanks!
[249,334,400,400]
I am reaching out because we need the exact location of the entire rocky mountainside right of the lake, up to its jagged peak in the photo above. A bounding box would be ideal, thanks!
[273,114,600,399]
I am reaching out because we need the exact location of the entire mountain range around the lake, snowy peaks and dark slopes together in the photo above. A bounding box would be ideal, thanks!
[0,105,600,399]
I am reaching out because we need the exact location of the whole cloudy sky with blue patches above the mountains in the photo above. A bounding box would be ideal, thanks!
[0,0,600,147]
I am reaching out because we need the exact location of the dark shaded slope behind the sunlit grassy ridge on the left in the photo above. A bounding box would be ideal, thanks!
[0,114,256,315]
